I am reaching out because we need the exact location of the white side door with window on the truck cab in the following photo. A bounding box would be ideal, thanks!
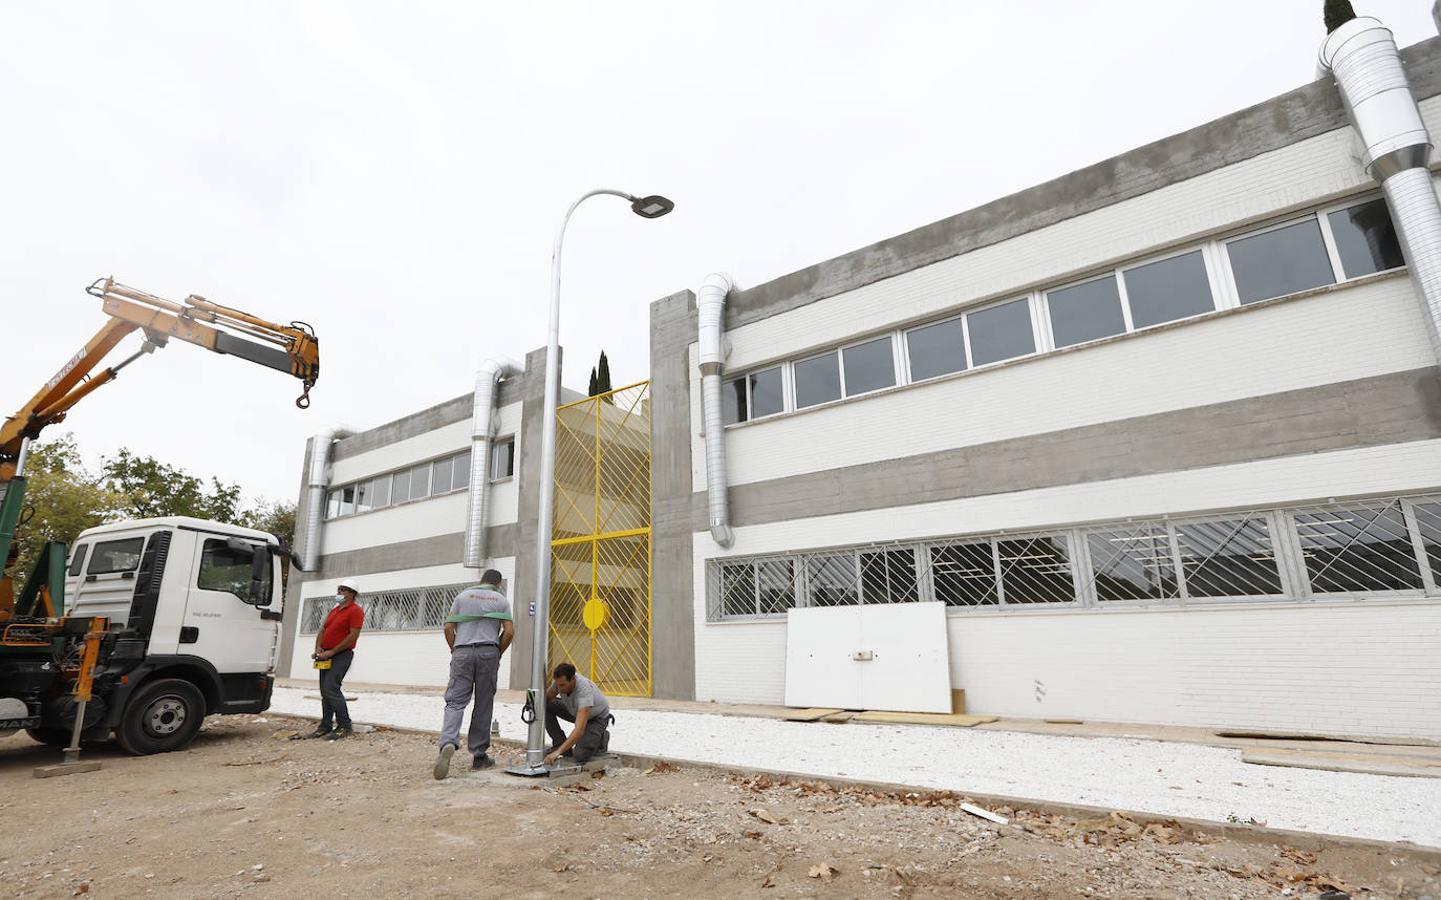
[179,534,278,675]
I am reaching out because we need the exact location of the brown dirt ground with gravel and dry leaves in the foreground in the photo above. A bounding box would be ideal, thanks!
[0,716,1441,900]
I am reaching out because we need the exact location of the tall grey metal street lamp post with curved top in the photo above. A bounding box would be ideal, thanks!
[507,187,676,776]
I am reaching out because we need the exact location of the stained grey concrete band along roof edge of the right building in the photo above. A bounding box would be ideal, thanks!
[725,37,1441,328]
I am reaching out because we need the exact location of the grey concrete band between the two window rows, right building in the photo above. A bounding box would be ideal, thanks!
[691,367,1441,532]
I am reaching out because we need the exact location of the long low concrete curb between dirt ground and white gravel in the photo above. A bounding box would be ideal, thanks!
[271,713,1441,865]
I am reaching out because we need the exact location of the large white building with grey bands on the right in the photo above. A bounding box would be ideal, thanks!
[653,20,1441,739]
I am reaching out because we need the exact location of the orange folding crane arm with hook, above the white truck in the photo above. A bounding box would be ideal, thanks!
[0,278,320,466]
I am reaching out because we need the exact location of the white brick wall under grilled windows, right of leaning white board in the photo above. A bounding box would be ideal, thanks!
[950,602,1441,739]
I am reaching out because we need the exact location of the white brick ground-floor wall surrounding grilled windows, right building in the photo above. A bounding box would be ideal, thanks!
[693,441,1441,737]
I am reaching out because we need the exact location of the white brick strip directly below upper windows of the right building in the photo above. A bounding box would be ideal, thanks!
[692,275,1435,490]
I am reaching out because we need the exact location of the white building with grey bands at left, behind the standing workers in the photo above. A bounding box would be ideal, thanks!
[272,351,564,688]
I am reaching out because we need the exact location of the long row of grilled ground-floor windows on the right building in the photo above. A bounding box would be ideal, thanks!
[706,495,1441,621]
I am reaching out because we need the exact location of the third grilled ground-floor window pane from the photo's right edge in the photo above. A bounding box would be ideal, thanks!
[1176,517,1281,598]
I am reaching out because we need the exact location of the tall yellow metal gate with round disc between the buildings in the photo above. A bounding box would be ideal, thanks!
[550,382,651,697]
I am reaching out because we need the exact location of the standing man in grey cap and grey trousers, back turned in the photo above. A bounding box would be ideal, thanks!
[434,569,516,780]
